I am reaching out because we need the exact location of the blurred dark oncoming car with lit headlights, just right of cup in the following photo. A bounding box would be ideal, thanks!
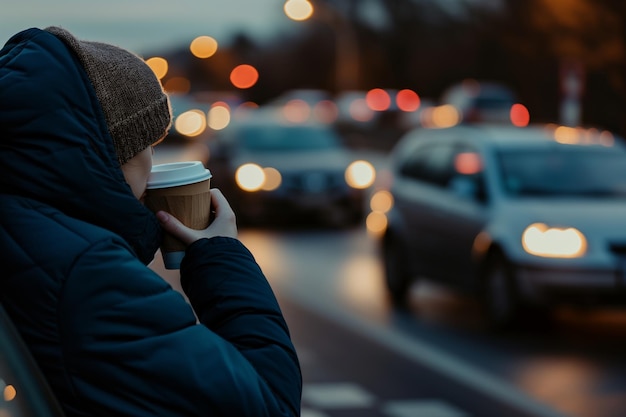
[207,112,375,226]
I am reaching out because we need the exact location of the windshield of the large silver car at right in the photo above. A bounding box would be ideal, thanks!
[498,147,626,197]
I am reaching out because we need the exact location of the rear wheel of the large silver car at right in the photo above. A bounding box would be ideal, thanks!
[383,235,413,307]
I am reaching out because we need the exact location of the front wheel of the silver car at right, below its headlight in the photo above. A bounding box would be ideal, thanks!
[483,255,521,330]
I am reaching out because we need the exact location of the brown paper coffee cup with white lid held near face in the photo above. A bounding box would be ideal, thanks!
[144,161,212,269]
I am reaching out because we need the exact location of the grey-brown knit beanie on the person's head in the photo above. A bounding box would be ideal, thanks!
[45,26,172,164]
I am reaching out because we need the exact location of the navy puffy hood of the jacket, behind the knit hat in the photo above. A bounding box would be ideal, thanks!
[0,28,161,263]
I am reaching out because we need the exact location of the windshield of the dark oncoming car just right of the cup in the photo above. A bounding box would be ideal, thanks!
[241,126,339,152]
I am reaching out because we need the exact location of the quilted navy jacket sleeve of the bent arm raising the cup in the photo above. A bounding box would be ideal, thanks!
[61,238,302,417]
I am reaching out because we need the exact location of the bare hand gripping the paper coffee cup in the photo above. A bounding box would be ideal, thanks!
[156,188,237,242]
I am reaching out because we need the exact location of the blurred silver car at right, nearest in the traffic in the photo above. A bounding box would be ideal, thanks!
[381,125,626,327]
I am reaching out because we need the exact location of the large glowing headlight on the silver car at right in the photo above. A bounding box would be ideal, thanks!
[522,223,587,258]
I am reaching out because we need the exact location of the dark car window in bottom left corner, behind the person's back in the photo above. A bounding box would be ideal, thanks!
[0,305,64,417]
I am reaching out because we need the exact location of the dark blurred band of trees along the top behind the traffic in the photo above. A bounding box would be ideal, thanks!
[158,0,626,136]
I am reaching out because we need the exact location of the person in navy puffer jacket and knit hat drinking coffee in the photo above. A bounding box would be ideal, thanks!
[0,27,302,417]
